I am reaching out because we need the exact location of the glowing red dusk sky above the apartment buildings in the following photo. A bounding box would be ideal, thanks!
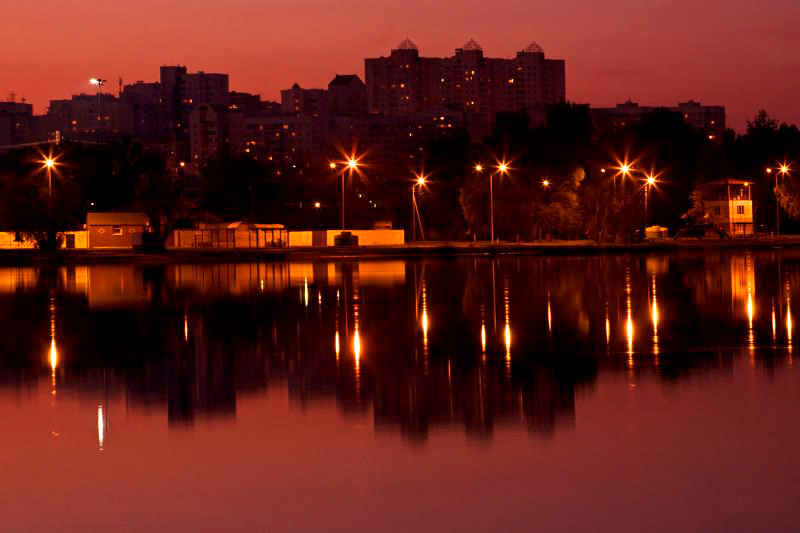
[0,0,800,131]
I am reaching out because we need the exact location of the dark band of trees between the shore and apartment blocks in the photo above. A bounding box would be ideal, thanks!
[0,103,800,248]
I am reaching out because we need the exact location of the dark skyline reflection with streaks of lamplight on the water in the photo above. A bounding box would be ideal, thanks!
[0,254,799,442]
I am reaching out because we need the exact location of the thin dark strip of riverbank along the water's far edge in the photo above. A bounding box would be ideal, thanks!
[0,235,800,266]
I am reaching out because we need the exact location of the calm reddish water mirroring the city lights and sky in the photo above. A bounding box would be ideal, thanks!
[0,252,800,531]
